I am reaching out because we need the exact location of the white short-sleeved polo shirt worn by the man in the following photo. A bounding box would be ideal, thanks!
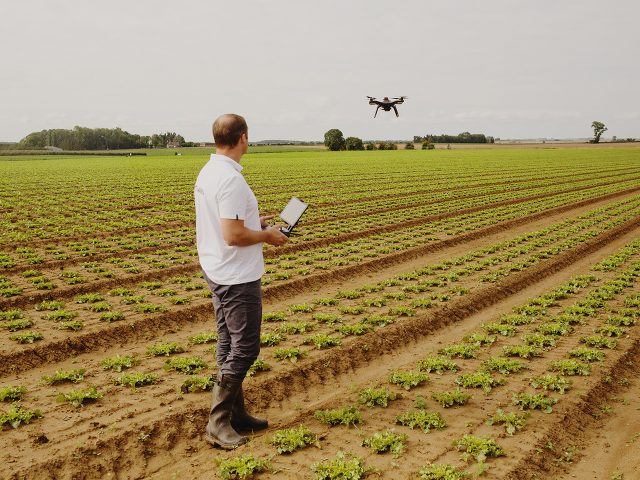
[194,154,264,285]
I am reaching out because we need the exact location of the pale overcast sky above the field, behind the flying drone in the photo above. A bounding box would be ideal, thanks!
[0,0,640,141]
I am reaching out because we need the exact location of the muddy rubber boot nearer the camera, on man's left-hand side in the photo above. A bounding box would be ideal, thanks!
[205,375,249,450]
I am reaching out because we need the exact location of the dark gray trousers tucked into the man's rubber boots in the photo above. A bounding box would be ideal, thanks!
[204,274,262,378]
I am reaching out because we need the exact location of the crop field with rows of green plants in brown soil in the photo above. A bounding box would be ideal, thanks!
[0,147,640,480]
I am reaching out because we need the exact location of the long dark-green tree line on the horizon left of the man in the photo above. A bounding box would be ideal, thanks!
[17,126,194,150]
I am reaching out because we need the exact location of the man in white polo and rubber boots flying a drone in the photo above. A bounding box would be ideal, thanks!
[194,114,288,449]
